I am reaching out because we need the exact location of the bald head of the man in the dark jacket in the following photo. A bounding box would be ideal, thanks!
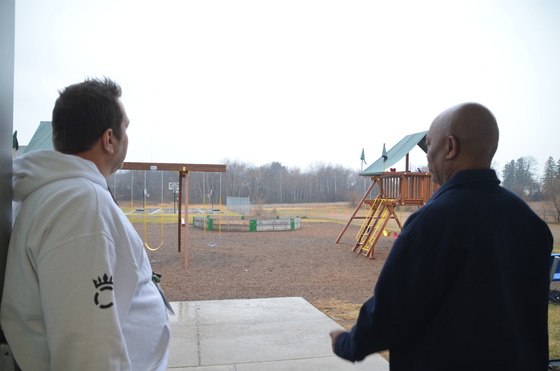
[426,103,499,184]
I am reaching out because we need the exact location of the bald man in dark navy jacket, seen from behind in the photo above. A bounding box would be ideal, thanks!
[331,103,553,371]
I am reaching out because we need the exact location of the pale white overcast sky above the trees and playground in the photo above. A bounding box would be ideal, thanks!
[14,0,560,176]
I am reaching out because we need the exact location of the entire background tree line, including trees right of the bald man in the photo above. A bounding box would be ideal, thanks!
[109,156,560,222]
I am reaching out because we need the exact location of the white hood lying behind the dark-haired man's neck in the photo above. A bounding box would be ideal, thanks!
[12,151,107,201]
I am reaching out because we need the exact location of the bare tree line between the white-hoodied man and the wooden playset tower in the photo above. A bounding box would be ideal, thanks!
[108,160,370,205]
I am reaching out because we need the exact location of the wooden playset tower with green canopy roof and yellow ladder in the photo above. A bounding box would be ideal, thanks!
[335,132,438,259]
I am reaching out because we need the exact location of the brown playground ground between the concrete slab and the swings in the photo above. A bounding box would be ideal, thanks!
[137,222,393,328]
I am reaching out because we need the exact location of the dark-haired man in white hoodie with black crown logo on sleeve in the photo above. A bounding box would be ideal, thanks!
[0,79,170,371]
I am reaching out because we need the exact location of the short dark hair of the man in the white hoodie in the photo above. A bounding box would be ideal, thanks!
[52,78,123,154]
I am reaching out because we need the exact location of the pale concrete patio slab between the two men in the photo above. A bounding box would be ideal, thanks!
[164,297,389,371]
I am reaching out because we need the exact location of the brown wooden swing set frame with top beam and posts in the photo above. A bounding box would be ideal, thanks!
[122,162,226,268]
